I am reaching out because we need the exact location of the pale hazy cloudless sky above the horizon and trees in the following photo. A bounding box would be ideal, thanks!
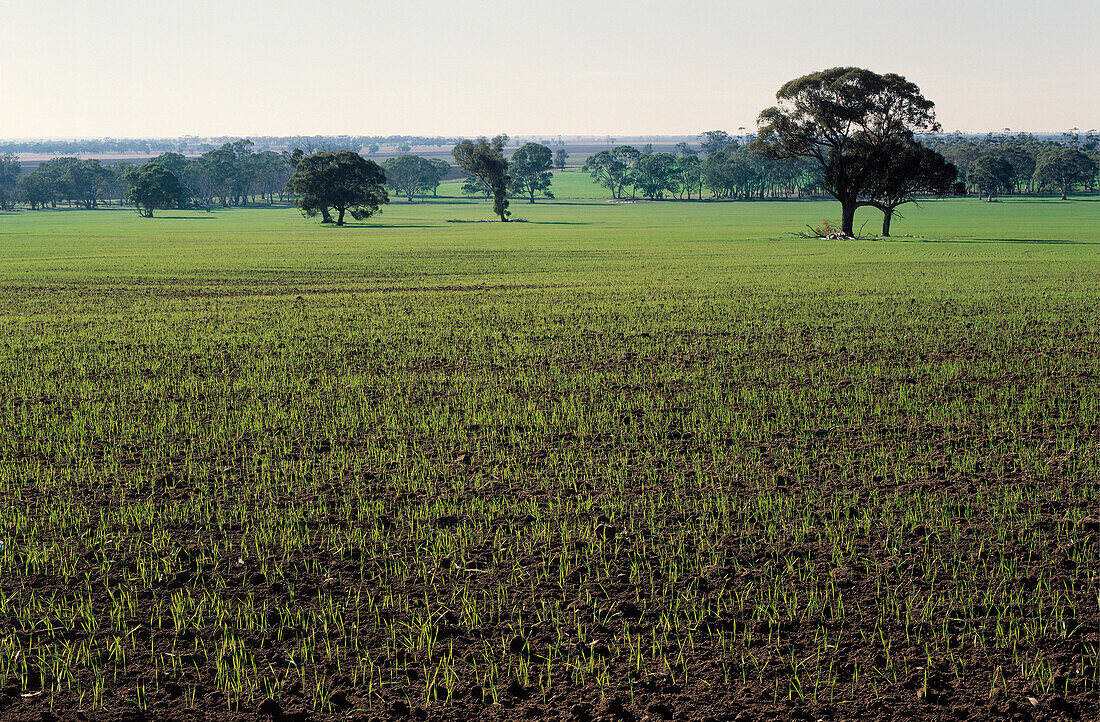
[0,0,1100,138]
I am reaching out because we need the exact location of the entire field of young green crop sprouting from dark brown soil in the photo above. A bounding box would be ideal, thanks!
[0,193,1100,722]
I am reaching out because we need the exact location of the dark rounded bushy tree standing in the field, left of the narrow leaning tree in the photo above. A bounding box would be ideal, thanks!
[286,151,389,226]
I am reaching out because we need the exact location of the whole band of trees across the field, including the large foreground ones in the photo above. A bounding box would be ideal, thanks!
[0,67,1100,231]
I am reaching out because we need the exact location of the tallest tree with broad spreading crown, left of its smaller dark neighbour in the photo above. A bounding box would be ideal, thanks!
[757,67,939,236]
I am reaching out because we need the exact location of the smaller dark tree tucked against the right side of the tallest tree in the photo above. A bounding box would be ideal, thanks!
[867,135,958,237]
